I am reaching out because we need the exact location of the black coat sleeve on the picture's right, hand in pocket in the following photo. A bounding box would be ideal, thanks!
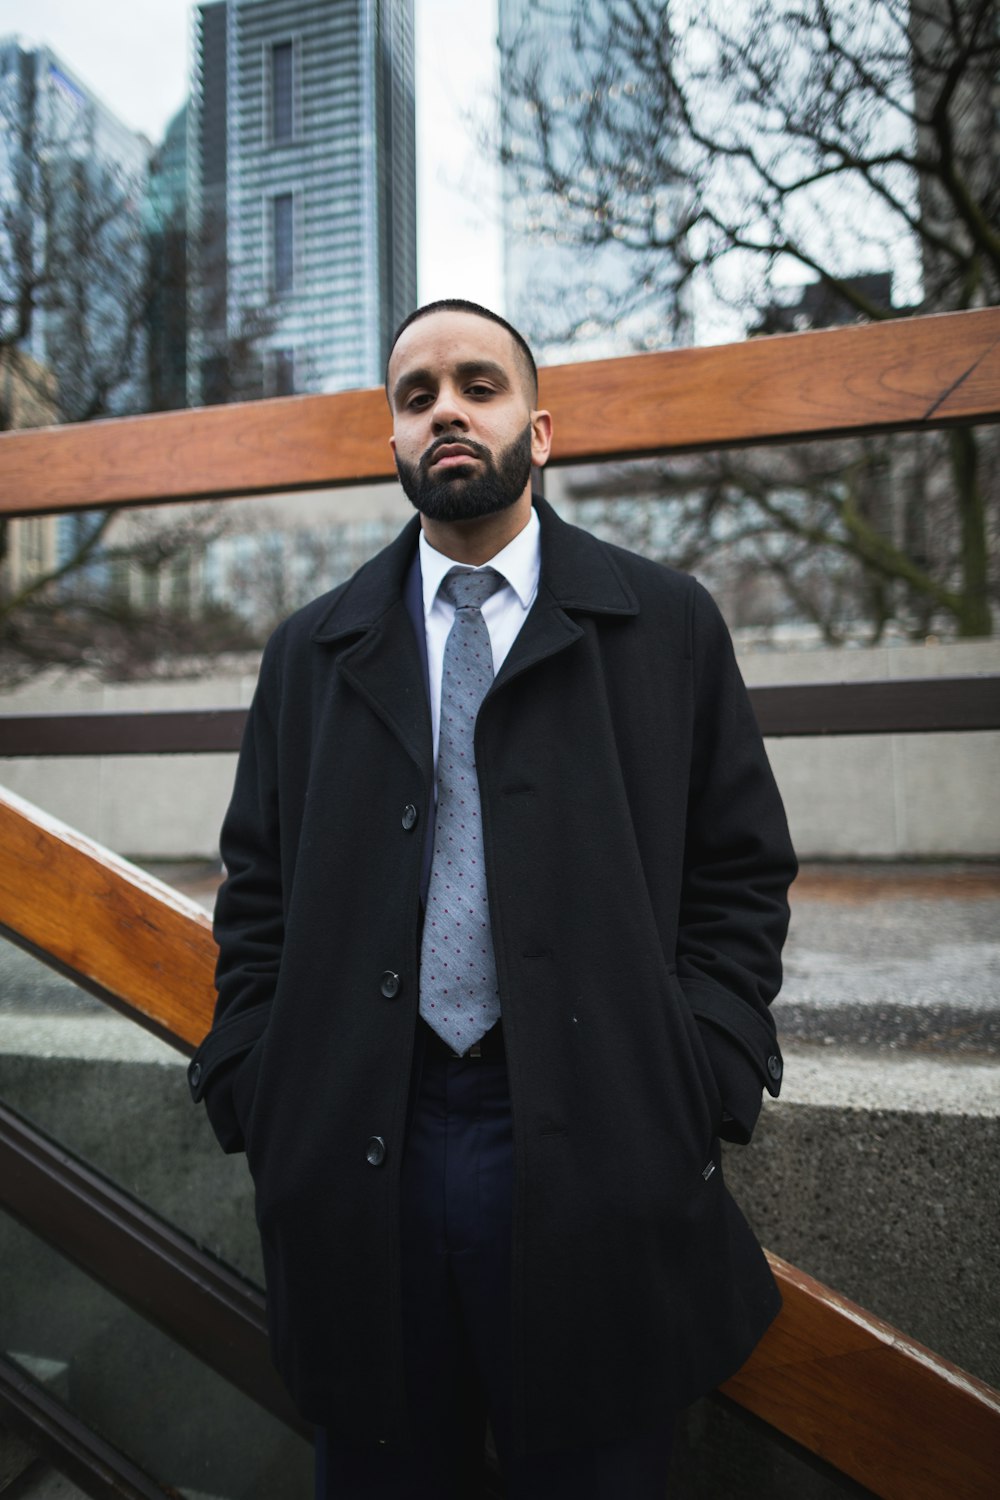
[678,585,796,1142]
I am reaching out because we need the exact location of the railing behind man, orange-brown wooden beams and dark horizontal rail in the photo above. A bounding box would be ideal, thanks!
[0,309,1000,1500]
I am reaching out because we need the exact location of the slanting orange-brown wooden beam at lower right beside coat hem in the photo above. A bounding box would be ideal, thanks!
[723,1256,1000,1500]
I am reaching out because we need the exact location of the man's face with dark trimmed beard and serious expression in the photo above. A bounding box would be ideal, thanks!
[388,312,549,522]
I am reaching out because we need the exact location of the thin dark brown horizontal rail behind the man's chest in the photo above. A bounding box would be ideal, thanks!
[0,672,1000,759]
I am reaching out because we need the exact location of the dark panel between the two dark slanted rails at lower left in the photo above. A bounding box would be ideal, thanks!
[0,1214,312,1500]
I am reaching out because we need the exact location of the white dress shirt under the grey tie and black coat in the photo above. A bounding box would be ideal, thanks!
[420,506,541,770]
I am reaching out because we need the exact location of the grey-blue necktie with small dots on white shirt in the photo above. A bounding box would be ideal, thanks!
[420,569,507,1056]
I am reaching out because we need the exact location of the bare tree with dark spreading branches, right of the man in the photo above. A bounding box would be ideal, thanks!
[502,0,1000,636]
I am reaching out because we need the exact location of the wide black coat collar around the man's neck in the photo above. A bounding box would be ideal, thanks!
[313,495,639,642]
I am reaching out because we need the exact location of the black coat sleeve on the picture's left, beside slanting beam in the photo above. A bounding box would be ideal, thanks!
[187,641,285,1152]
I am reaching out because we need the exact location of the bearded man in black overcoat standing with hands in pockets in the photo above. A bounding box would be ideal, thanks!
[190,302,795,1500]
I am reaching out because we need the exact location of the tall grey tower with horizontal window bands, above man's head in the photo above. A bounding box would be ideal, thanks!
[187,0,417,404]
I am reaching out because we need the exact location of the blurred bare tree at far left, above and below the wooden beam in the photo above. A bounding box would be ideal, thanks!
[0,71,267,680]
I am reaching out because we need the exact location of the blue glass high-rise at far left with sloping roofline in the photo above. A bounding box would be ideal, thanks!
[0,38,150,420]
